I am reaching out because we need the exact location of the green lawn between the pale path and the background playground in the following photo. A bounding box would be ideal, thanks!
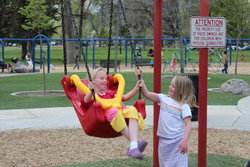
[0,72,250,109]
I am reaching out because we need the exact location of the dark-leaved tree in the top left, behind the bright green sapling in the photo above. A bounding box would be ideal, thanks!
[0,0,58,57]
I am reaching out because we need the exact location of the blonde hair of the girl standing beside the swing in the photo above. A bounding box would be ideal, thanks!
[173,76,197,107]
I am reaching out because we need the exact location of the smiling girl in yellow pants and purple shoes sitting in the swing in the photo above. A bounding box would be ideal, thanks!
[84,68,148,159]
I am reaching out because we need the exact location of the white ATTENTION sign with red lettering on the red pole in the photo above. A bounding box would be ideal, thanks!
[190,16,226,48]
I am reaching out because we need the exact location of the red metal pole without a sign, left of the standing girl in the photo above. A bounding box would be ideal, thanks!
[153,0,162,167]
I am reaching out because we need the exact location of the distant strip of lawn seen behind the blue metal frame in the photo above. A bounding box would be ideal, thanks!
[2,46,250,64]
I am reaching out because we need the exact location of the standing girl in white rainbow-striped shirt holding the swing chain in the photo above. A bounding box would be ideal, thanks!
[139,76,196,167]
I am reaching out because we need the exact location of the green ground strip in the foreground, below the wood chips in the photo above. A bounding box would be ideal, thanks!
[53,154,247,167]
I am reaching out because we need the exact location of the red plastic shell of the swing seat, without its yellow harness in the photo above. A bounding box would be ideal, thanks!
[61,75,146,138]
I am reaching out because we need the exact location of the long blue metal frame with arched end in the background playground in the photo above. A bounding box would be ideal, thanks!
[0,34,250,73]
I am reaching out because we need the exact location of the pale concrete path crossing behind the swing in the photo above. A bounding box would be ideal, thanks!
[0,96,250,131]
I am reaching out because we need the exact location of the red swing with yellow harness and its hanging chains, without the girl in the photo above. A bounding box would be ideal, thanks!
[61,0,146,138]
